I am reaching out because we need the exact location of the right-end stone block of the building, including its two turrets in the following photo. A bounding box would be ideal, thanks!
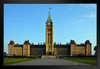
[70,40,92,56]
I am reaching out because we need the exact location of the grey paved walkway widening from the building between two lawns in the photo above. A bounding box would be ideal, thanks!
[11,58,88,66]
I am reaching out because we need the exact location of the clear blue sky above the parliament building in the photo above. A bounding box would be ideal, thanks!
[4,4,97,54]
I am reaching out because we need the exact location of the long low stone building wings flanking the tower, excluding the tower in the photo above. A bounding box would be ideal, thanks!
[8,40,92,56]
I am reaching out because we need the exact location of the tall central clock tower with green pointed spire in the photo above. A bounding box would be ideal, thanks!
[46,12,54,55]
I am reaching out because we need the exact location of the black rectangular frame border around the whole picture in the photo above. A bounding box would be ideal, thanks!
[0,0,100,69]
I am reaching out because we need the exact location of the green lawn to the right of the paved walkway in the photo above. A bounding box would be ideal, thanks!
[61,57,97,65]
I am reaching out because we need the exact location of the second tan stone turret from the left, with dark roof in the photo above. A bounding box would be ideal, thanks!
[23,40,30,56]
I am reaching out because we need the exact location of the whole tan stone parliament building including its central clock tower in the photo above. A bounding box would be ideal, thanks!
[8,12,92,56]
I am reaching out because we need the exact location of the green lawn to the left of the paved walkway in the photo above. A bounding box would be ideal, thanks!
[4,58,38,65]
